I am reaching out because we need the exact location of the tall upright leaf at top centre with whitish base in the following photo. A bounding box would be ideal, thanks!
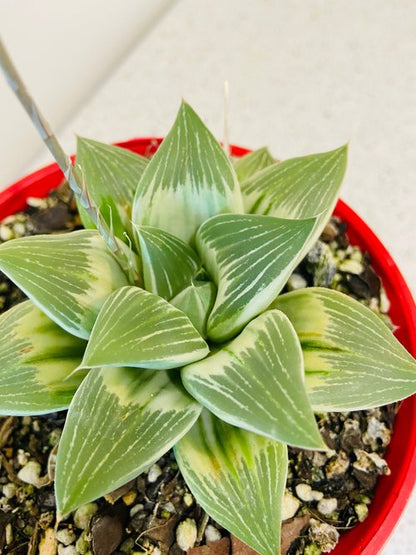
[133,102,244,243]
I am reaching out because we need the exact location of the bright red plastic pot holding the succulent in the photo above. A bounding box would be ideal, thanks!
[0,138,416,555]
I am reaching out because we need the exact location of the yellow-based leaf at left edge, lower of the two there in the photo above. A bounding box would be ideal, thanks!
[0,301,85,415]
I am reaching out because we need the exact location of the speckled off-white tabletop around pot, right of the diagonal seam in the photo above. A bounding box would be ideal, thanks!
[0,0,416,555]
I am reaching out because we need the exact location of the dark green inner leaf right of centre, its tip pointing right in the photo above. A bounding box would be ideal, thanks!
[196,214,315,342]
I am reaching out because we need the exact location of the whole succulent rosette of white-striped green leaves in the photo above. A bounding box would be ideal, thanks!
[0,103,416,554]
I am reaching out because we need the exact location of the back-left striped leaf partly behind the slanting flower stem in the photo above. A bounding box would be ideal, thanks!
[76,137,149,241]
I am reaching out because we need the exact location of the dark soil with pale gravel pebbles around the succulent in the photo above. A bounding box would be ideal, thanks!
[0,186,397,555]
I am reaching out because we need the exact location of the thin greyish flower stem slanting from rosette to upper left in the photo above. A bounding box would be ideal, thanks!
[0,38,138,281]
